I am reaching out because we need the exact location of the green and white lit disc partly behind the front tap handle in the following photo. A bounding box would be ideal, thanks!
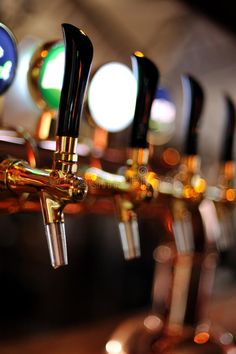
[38,43,65,109]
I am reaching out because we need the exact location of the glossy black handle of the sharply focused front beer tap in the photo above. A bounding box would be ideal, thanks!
[57,23,93,138]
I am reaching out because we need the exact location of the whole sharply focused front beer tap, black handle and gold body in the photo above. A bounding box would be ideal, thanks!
[0,24,93,268]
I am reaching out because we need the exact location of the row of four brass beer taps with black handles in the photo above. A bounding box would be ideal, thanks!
[0,24,236,274]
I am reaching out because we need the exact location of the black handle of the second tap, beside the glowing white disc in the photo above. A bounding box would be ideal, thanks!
[130,52,159,148]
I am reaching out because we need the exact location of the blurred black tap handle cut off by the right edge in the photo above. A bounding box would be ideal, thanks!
[220,95,236,162]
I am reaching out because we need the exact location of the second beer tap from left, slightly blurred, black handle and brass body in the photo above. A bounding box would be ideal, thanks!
[85,51,159,259]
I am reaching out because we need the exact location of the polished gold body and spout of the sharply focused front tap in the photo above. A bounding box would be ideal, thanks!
[0,137,87,268]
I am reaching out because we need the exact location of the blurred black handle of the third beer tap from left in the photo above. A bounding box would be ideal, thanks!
[182,75,204,155]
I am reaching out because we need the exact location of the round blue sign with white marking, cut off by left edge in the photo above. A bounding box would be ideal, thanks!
[0,23,17,95]
